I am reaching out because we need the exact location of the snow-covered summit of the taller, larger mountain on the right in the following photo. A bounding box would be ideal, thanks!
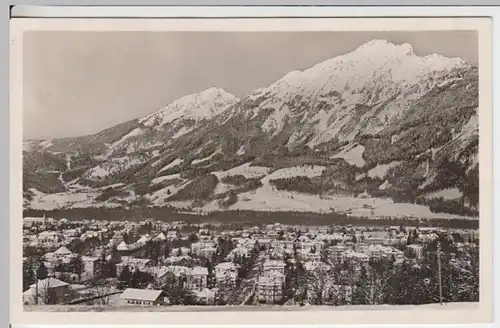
[268,40,468,97]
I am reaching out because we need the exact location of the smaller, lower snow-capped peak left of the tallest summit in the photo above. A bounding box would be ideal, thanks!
[140,87,239,128]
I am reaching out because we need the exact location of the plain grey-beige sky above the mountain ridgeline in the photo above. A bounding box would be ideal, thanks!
[24,31,478,139]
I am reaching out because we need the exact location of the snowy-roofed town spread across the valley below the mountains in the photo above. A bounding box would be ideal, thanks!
[23,216,479,307]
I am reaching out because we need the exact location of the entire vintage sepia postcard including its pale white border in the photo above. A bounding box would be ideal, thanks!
[10,14,492,324]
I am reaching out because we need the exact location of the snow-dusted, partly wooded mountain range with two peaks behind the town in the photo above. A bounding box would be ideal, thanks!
[25,40,479,220]
